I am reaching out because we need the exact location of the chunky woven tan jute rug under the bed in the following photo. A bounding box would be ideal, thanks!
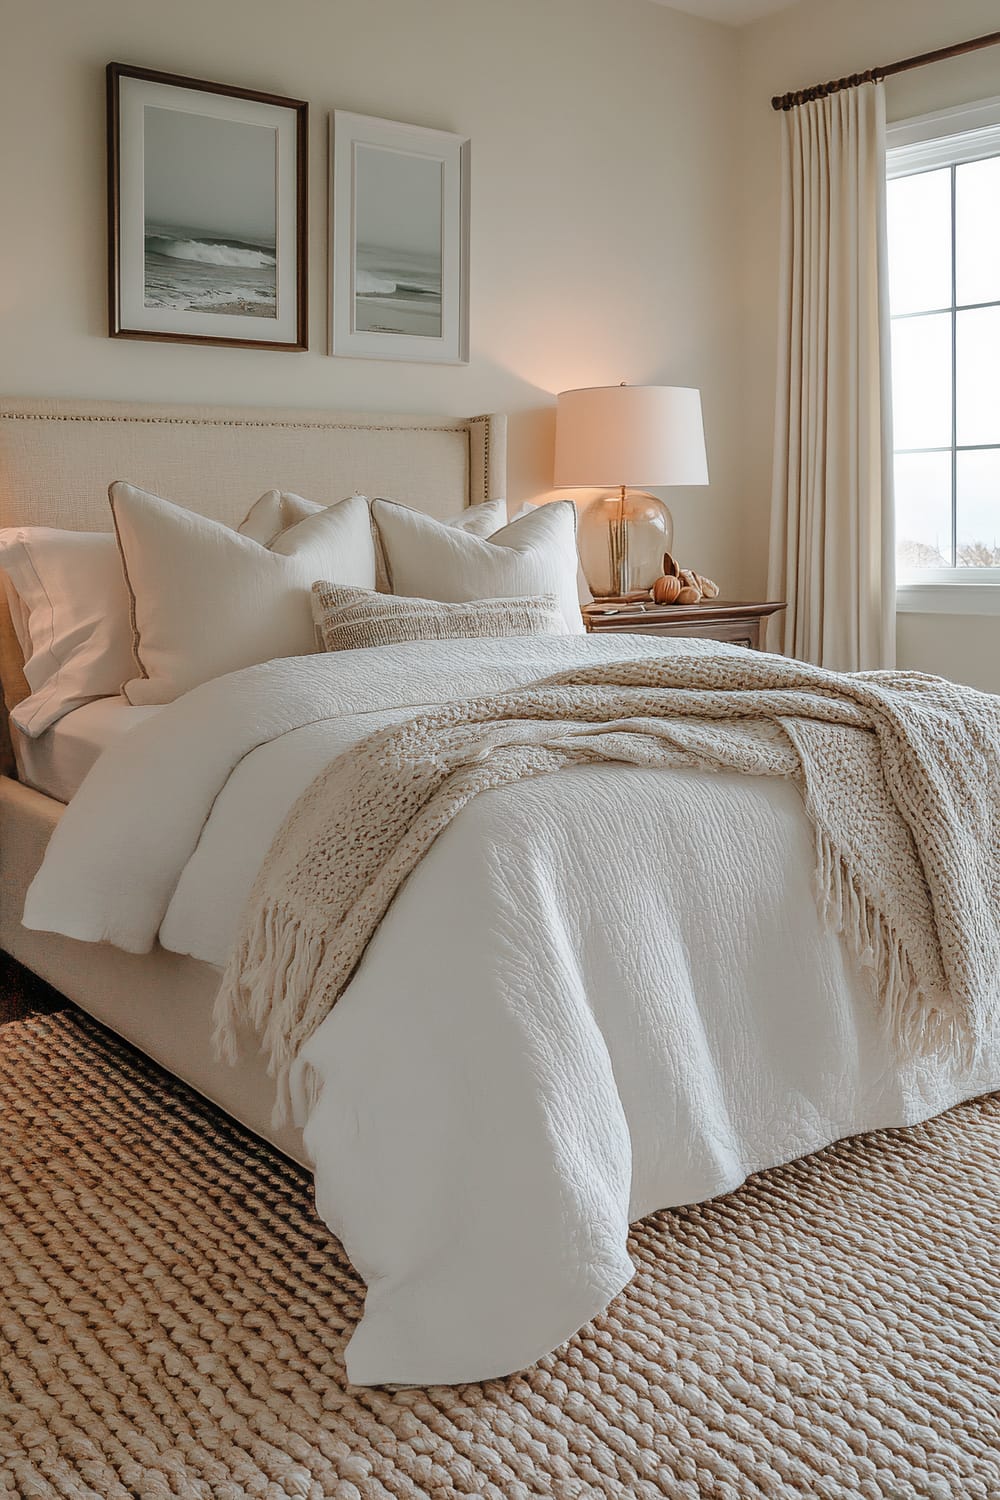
[0,1013,1000,1500]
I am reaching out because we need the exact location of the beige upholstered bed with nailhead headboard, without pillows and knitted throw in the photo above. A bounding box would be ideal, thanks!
[0,404,1000,1385]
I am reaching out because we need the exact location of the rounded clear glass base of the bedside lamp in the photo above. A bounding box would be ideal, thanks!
[577,489,673,599]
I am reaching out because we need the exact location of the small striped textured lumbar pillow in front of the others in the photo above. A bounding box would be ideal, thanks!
[312,579,567,651]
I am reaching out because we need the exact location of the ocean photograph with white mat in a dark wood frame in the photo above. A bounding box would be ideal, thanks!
[108,63,309,350]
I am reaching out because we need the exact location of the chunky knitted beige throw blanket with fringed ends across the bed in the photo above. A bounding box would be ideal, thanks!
[216,653,1000,1115]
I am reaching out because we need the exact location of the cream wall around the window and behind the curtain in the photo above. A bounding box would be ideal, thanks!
[739,0,1000,692]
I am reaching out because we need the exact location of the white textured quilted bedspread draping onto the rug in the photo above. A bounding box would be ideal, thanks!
[25,638,1000,1385]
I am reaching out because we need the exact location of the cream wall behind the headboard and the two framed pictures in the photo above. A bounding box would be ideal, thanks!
[0,0,750,596]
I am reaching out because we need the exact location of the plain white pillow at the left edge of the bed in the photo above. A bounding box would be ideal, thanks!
[0,527,133,740]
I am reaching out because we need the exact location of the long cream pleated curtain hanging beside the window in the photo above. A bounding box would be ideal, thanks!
[768,84,895,672]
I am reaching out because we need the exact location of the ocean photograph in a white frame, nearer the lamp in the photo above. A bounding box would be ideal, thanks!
[330,110,469,365]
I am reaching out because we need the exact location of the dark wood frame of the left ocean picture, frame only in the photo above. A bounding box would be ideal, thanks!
[106,63,309,350]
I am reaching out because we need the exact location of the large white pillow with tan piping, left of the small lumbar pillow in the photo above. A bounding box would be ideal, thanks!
[108,480,375,704]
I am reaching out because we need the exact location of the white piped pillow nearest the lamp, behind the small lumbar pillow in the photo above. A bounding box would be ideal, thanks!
[372,500,583,635]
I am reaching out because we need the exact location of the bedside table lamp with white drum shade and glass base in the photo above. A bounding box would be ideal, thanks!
[553,386,708,599]
